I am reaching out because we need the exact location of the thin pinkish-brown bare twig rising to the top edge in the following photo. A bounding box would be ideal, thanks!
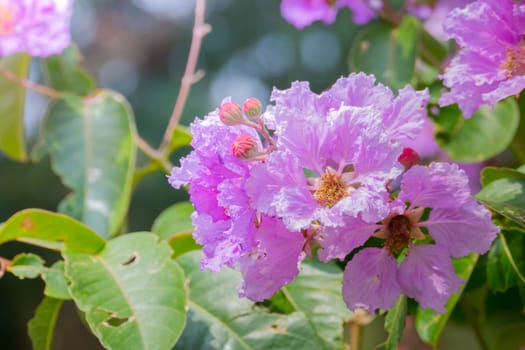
[159,0,211,154]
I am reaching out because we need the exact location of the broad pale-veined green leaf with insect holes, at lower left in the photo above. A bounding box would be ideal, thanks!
[64,233,186,350]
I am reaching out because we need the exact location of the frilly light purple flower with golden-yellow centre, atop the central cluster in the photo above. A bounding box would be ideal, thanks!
[246,73,428,231]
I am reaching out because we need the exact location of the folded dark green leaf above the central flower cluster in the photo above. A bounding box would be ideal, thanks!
[348,16,421,89]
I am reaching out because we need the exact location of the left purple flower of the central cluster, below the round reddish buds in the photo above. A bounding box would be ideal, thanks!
[168,100,309,301]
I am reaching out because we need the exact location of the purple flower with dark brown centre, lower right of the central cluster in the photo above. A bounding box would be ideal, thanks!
[338,163,499,312]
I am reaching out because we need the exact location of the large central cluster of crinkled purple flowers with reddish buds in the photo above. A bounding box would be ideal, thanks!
[169,73,498,312]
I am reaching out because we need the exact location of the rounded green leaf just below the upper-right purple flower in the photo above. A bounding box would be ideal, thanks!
[435,99,520,162]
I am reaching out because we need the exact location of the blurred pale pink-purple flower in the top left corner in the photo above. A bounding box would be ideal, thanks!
[0,0,73,57]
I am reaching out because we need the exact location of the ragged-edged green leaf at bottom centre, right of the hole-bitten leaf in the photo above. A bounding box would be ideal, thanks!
[175,251,326,350]
